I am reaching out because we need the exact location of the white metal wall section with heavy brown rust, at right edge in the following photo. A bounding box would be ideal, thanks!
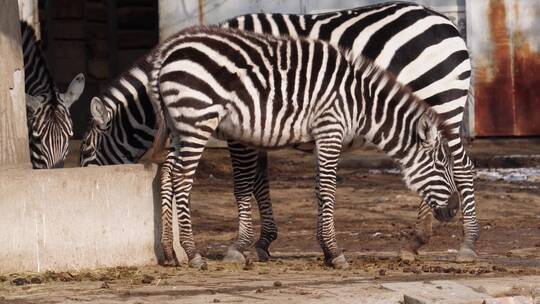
[467,0,540,136]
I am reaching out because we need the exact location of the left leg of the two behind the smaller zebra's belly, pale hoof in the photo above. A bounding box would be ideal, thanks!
[223,141,258,263]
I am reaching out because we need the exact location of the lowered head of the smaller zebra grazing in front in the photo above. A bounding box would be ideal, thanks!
[402,110,460,221]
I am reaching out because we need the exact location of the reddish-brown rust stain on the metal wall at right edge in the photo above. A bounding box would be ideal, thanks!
[475,0,540,136]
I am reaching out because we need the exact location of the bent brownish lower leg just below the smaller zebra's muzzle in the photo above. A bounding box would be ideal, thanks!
[399,201,433,261]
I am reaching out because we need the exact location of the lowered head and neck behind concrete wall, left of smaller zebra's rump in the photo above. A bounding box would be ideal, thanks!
[80,56,156,167]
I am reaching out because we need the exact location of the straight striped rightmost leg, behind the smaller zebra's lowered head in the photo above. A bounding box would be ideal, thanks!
[454,150,479,263]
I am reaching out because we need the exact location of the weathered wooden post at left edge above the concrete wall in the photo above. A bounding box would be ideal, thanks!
[0,1,31,171]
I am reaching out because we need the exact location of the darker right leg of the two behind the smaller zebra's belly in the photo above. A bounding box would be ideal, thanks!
[253,151,278,262]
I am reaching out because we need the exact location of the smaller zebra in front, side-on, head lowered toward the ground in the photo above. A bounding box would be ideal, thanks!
[83,27,459,268]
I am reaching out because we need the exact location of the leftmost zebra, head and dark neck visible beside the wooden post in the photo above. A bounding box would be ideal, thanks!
[21,21,84,169]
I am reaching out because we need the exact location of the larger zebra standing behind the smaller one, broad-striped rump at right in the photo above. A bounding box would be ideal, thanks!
[81,2,478,264]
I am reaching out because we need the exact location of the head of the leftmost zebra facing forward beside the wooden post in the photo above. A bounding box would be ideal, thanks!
[26,74,85,169]
